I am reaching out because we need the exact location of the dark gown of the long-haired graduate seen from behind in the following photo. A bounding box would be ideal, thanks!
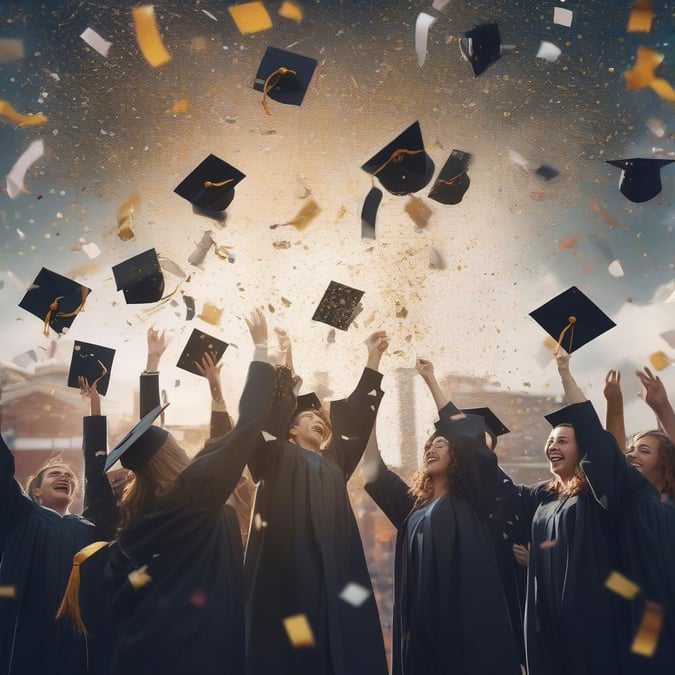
[106,361,274,675]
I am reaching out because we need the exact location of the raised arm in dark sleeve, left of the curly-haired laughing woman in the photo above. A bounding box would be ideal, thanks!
[361,425,415,529]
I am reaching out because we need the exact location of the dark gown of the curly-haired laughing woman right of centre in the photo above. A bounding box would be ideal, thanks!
[366,409,520,675]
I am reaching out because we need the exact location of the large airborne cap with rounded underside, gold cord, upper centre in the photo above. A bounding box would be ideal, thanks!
[361,122,434,195]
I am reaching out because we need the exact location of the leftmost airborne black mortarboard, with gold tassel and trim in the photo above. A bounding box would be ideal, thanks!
[19,267,91,335]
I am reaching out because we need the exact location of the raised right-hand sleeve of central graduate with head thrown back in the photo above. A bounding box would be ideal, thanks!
[330,368,384,480]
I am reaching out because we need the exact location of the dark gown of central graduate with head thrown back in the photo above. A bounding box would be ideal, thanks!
[245,368,387,675]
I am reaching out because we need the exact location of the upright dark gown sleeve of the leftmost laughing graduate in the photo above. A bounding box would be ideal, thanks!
[82,415,117,539]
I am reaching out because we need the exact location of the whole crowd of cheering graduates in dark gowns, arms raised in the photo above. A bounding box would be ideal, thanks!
[0,309,675,675]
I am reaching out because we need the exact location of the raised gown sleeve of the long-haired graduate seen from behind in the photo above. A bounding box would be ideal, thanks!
[177,361,274,511]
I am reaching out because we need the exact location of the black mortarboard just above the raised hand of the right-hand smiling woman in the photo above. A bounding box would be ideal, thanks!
[530,286,616,354]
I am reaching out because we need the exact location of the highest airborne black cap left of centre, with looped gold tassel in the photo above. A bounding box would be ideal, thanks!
[253,47,316,105]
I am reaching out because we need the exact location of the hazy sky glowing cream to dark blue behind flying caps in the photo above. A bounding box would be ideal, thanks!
[0,0,675,468]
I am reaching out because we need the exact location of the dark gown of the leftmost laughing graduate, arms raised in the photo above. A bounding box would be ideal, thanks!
[0,416,114,675]
